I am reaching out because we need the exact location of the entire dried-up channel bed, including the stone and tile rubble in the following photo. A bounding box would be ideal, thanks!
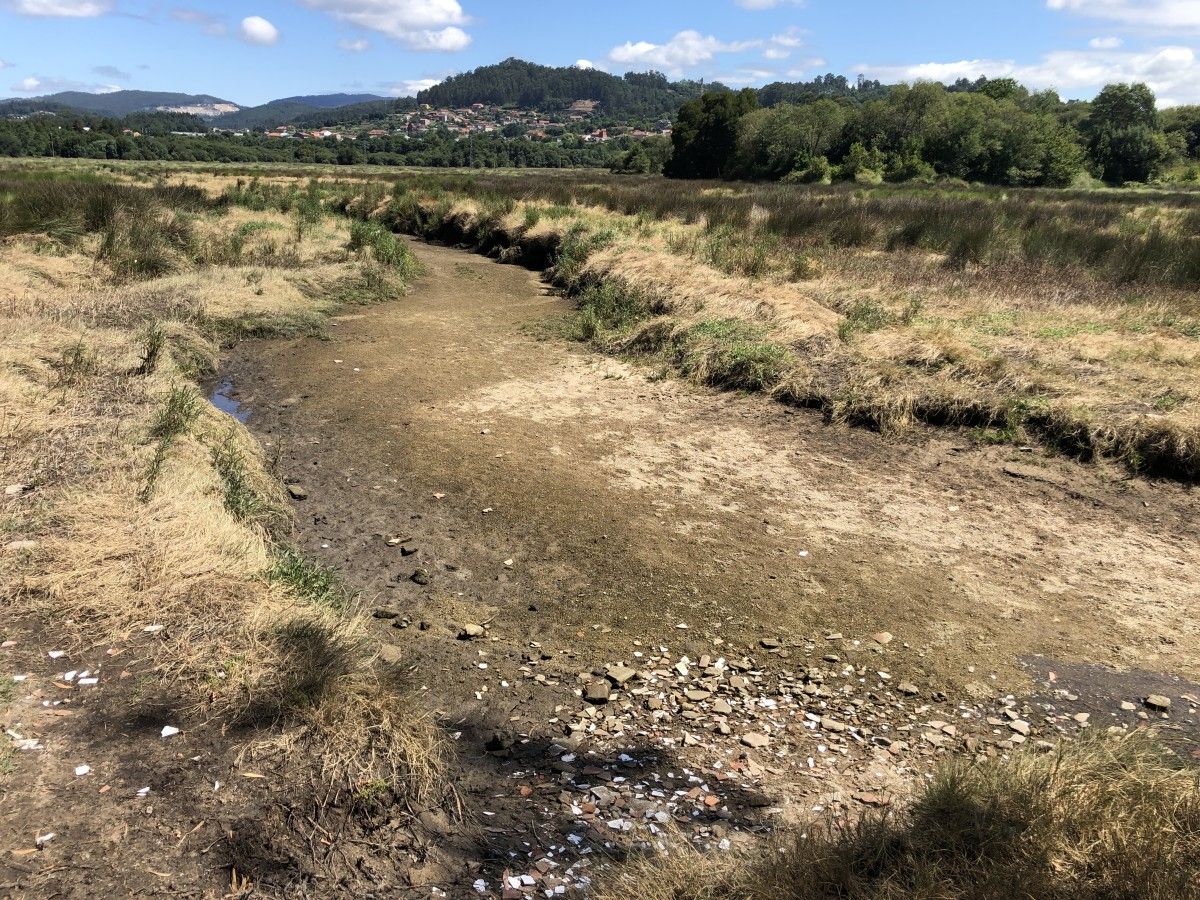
[223,245,1200,896]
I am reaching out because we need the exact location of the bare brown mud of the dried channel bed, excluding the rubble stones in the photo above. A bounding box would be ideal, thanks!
[224,237,1200,897]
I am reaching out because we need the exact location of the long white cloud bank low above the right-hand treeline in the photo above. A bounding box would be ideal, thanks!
[858,46,1200,107]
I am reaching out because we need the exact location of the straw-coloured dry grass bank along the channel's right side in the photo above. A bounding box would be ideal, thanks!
[384,188,1200,480]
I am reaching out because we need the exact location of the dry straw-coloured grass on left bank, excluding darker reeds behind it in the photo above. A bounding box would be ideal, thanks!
[0,170,442,792]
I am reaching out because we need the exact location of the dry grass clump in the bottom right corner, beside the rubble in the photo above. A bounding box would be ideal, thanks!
[595,732,1200,900]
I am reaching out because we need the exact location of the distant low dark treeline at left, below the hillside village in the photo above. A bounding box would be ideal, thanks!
[0,113,638,172]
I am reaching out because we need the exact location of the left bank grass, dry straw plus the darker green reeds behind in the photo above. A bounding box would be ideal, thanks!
[0,173,440,811]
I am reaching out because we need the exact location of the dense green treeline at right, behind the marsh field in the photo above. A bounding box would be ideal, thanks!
[667,79,1200,186]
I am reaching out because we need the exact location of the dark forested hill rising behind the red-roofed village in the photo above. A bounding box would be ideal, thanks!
[416,59,724,119]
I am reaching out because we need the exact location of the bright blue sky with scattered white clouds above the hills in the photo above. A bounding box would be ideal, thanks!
[7,0,1200,106]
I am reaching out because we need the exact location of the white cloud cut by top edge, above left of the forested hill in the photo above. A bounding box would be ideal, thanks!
[299,0,470,53]
